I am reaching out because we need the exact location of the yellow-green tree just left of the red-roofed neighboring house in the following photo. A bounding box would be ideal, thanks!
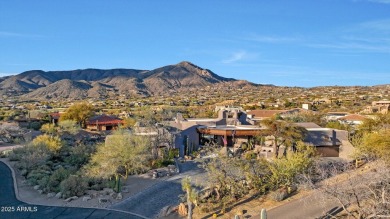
[60,103,94,127]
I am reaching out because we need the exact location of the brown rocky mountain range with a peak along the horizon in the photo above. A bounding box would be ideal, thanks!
[0,61,261,100]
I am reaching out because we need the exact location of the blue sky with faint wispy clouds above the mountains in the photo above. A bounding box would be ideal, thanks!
[0,0,390,87]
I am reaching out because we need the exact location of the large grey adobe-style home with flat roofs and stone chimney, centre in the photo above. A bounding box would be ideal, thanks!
[170,107,352,157]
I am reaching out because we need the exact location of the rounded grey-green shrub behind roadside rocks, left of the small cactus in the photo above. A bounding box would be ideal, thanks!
[60,175,88,198]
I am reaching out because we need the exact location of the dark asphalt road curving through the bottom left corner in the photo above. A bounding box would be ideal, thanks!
[0,161,147,219]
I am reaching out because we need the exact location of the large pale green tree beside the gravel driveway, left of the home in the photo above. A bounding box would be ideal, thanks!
[86,130,151,191]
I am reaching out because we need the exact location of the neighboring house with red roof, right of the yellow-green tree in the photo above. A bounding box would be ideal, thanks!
[86,114,124,131]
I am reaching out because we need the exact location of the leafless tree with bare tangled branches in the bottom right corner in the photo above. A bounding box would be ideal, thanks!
[301,161,390,219]
